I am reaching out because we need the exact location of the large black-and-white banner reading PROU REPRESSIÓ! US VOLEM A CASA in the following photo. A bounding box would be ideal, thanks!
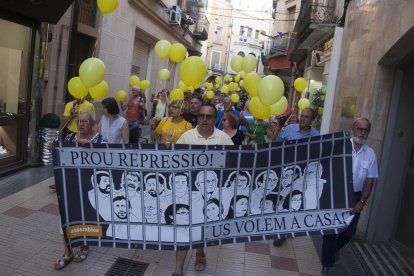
[54,133,354,250]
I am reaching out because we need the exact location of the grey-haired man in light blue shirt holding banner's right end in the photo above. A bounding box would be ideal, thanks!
[322,118,378,275]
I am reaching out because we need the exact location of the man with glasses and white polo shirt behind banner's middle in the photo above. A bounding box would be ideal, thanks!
[172,103,233,276]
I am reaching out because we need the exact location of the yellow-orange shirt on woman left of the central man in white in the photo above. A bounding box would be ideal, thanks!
[155,117,193,144]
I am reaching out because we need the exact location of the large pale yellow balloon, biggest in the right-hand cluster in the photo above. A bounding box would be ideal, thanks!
[258,75,285,105]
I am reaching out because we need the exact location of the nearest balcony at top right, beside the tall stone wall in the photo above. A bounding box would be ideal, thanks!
[289,0,338,62]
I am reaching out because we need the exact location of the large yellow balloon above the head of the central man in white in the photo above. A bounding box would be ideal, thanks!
[180,56,207,86]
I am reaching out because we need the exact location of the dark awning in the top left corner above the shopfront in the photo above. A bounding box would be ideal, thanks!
[0,0,73,24]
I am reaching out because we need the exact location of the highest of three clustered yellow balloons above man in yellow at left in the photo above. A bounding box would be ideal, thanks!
[79,58,106,88]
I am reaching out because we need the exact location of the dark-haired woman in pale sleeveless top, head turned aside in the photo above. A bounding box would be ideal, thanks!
[98,97,129,144]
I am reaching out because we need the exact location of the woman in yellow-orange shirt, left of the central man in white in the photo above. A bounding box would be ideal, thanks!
[155,100,193,144]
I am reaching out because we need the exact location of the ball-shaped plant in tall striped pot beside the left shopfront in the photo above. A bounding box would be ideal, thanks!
[39,113,60,165]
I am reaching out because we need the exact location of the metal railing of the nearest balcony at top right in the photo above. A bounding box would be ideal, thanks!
[295,0,337,37]
